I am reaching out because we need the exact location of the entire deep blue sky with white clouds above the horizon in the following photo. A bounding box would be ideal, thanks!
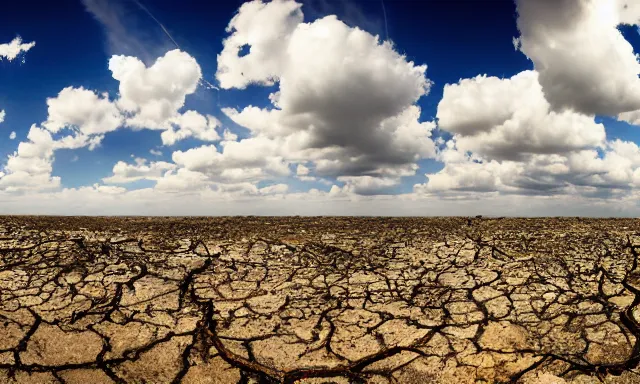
[0,0,640,215]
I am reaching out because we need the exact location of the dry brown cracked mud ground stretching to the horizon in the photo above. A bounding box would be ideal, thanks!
[0,217,640,384]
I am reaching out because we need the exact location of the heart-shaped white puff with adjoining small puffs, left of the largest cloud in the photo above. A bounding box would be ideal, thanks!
[28,49,201,144]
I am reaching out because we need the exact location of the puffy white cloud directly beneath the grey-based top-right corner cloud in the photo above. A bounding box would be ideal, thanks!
[437,71,606,160]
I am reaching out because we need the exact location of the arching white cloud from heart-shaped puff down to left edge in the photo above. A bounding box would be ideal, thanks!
[0,50,210,190]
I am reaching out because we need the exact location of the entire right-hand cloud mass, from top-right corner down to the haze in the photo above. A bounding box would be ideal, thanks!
[422,0,640,198]
